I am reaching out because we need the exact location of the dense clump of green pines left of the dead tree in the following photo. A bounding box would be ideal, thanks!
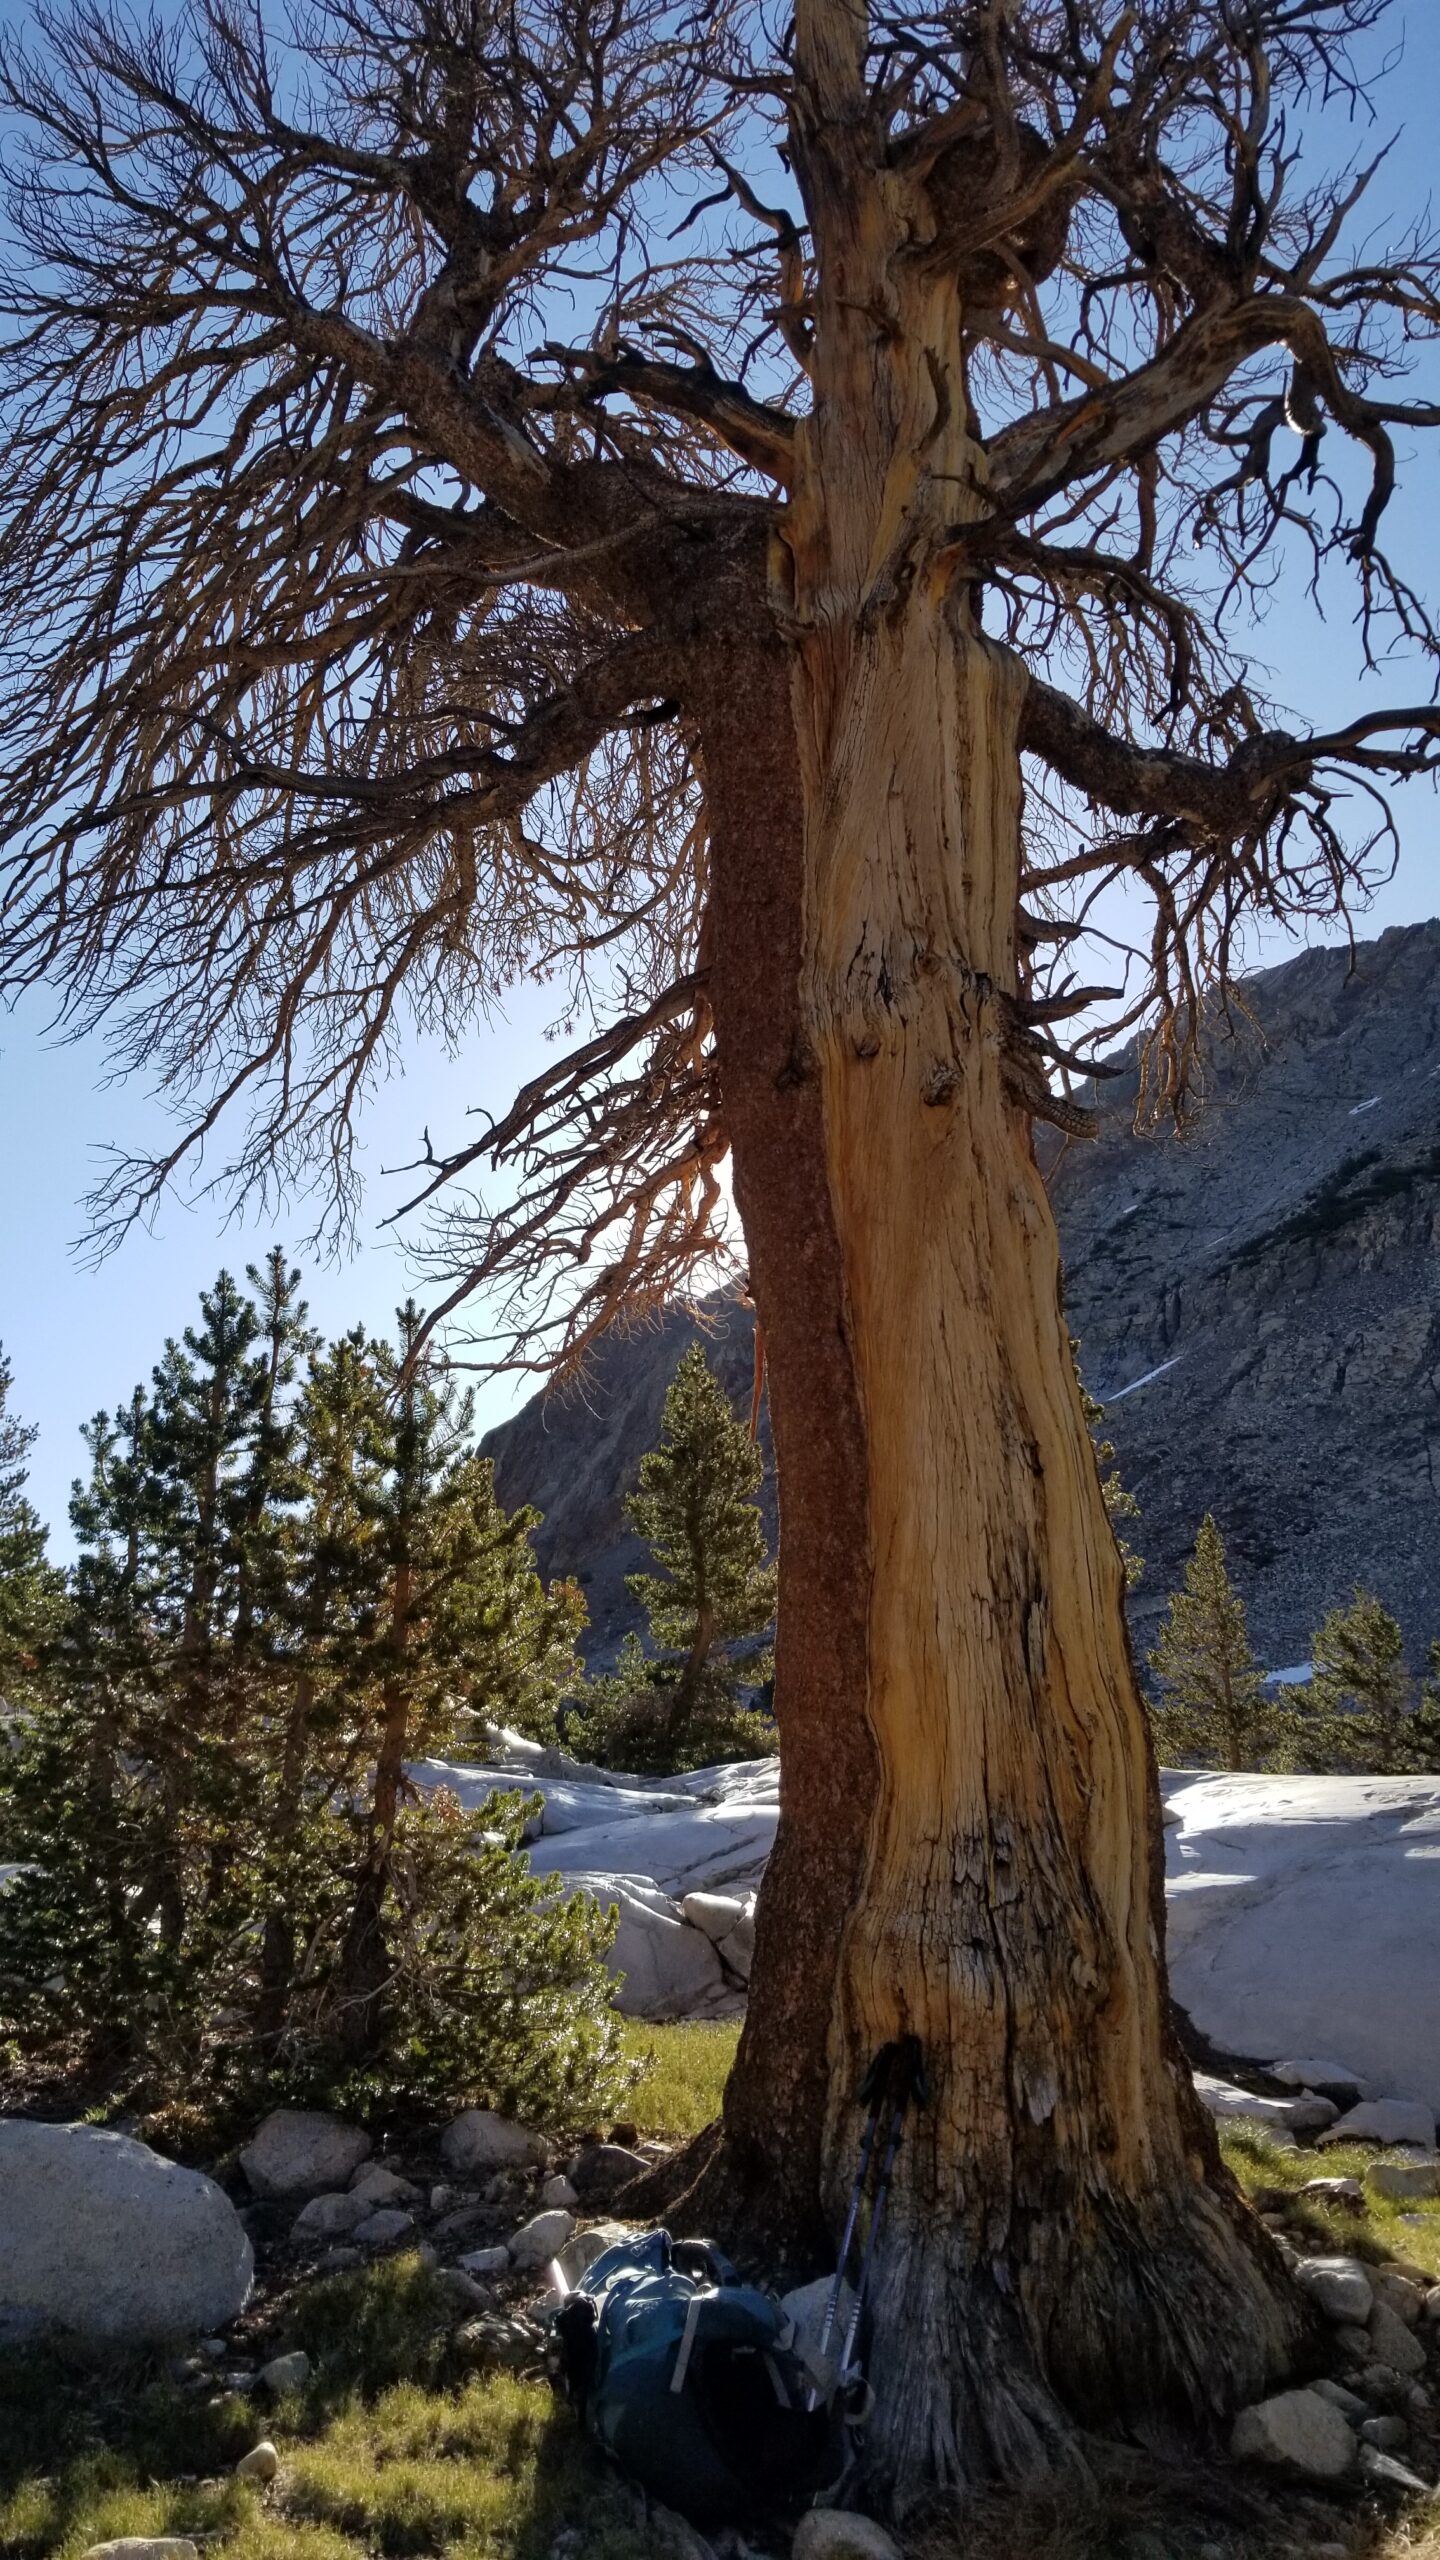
[0,1254,614,2117]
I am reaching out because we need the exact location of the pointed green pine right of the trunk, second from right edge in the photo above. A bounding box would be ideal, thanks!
[1150,1510,1289,1769]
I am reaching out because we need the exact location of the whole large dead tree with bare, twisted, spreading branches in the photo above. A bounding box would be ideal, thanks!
[0,0,1440,2501]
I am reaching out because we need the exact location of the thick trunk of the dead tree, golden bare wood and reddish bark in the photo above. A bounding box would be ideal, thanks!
[676,35,1304,2506]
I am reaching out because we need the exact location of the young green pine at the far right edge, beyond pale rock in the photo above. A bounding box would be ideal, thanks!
[1294,1585,1440,1777]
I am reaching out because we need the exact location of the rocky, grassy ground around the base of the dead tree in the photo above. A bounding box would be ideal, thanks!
[0,2078,1440,2560]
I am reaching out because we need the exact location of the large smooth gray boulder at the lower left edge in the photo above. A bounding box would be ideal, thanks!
[0,2117,254,2342]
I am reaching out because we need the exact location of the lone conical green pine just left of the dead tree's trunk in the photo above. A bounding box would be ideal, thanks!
[571,1344,776,1772]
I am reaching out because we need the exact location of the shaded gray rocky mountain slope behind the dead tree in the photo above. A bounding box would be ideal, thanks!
[487,922,1440,1667]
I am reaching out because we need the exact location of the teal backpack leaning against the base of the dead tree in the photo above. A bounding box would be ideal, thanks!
[551,2230,835,2524]
